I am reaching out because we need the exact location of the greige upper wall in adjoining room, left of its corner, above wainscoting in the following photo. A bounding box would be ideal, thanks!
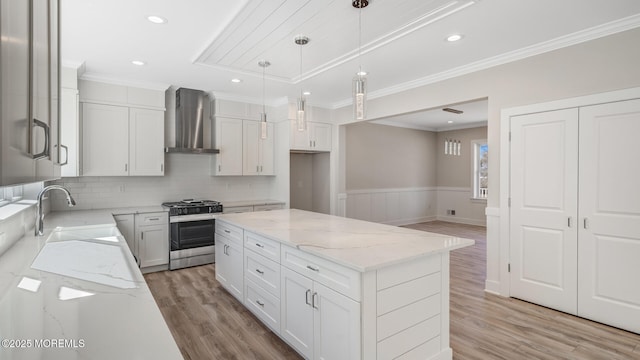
[345,122,436,190]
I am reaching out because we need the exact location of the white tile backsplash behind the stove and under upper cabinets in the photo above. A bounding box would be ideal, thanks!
[51,154,275,210]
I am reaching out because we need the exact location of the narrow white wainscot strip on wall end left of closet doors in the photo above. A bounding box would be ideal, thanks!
[484,207,504,295]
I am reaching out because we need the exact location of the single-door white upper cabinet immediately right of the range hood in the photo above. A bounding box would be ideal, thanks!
[211,117,243,175]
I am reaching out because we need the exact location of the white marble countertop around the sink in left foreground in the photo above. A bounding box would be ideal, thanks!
[0,207,182,360]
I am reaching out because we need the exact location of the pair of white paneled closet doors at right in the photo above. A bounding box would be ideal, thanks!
[510,100,640,333]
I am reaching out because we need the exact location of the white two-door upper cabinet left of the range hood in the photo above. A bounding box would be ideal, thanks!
[81,103,164,176]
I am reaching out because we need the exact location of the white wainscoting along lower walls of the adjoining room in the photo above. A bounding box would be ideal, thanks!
[338,187,486,226]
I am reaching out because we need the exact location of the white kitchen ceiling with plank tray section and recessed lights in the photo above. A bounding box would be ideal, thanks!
[61,0,640,128]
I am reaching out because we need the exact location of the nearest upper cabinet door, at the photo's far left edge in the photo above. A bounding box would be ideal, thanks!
[0,1,35,185]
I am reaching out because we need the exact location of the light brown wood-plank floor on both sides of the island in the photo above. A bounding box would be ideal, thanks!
[145,221,640,360]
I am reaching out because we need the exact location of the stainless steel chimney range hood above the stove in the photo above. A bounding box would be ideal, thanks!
[165,88,220,154]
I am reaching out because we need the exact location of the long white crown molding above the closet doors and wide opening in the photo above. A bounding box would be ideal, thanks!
[331,14,640,109]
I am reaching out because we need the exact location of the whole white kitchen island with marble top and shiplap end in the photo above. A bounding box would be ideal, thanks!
[216,209,473,360]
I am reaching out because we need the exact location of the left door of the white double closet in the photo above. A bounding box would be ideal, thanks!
[510,109,578,314]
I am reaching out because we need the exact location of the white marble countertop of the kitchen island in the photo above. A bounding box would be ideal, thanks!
[218,209,475,272]
